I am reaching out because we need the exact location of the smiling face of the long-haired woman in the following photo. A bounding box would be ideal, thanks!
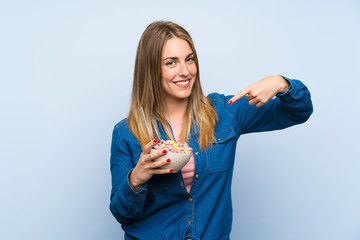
[161,38,197,103]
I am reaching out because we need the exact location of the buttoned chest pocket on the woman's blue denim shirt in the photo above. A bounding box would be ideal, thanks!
[206,127,236,173]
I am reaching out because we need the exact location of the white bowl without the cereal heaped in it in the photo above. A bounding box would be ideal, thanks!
[150,148,192,173]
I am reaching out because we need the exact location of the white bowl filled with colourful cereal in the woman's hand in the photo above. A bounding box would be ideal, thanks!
[150,140,192,173]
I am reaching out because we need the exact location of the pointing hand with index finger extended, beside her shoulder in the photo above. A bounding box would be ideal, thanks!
[228,75,290,107]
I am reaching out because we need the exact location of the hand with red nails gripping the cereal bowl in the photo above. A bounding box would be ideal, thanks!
[129,139,173,191]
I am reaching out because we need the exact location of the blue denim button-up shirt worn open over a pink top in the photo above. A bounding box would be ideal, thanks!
[110,76,313,240]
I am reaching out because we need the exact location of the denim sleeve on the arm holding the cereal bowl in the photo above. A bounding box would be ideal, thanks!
[110,124,147,224]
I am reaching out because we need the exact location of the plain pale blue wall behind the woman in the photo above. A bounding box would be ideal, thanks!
[0,0,360,240]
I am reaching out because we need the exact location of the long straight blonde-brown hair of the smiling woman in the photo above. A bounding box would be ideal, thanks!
[128,21,218,150]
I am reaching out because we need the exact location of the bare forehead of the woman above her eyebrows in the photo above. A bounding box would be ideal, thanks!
[162,38,192,58]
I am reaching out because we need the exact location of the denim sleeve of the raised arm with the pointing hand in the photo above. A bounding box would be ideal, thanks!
[211,77,313,134]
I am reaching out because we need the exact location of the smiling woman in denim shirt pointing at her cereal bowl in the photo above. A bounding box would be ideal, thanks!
[110,21,312,239]
